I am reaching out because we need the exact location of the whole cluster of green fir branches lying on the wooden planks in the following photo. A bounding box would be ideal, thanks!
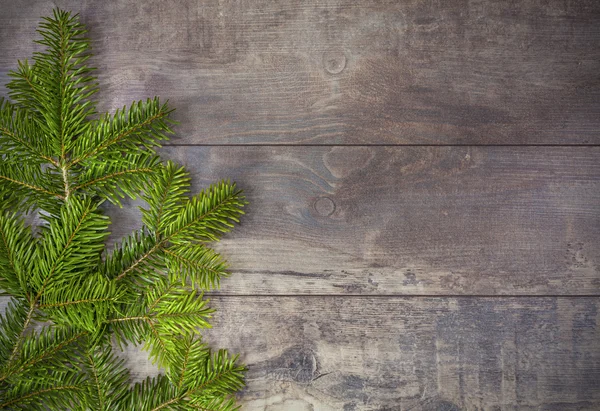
[0,9,246,411]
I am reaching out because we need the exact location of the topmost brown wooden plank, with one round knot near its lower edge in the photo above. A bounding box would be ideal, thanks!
[0,0,600,144]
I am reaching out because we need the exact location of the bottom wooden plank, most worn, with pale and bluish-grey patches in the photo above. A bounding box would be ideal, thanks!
[116,296,600,411]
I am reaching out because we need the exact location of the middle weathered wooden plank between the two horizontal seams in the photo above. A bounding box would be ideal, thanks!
[102,147,600,295]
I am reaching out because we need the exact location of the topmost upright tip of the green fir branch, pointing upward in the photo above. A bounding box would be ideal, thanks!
[8,10,97,158]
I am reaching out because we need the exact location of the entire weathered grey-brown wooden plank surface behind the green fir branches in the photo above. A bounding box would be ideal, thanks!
[0,0,600,411]
